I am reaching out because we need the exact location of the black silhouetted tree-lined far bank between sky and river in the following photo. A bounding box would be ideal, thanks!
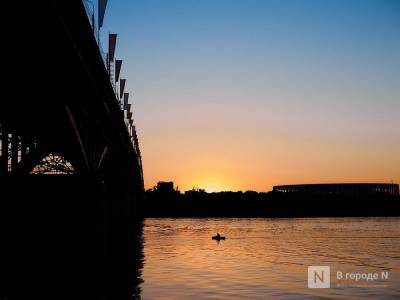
[141,182,400,217]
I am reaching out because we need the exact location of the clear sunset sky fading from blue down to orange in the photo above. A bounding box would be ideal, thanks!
[103,0,400,191]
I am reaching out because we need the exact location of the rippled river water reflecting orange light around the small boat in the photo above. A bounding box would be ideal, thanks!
[135,218,400,299]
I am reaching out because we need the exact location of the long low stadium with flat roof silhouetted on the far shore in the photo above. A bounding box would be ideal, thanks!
[273,183,399,195]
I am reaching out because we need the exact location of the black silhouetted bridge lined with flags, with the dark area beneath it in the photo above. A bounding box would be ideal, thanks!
[0,0,144,299]
